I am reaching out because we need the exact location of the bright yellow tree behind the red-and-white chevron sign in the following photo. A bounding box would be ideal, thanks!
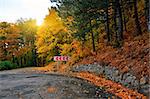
[36,7,69,64]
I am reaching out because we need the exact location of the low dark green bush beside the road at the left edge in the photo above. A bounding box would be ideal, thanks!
[0,61,17,70]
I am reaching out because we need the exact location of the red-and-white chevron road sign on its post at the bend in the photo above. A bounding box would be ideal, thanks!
[54,56,69,70]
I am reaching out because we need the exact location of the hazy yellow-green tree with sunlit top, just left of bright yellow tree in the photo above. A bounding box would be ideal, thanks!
[16,19,37,66]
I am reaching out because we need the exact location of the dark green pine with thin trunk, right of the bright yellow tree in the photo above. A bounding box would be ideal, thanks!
[52,0,107,52]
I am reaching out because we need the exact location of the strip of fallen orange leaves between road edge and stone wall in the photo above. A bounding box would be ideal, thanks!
[73,72,146,99]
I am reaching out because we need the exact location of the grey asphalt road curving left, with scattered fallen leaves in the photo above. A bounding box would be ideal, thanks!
[0,70,118,99]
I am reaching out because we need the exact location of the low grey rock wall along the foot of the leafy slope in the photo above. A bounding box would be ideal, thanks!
[71,63,150,96]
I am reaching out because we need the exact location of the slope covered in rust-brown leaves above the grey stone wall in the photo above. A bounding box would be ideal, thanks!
[77,33,150,78]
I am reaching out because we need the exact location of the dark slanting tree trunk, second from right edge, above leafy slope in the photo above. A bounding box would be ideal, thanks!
[133,0,142,36]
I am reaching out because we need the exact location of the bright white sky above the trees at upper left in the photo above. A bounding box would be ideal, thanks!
[0,0,52,25]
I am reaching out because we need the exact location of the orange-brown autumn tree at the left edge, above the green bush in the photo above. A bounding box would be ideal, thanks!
[0,22,21,60]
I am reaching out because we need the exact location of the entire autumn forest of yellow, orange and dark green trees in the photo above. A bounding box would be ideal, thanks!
[0,0,150,70]
